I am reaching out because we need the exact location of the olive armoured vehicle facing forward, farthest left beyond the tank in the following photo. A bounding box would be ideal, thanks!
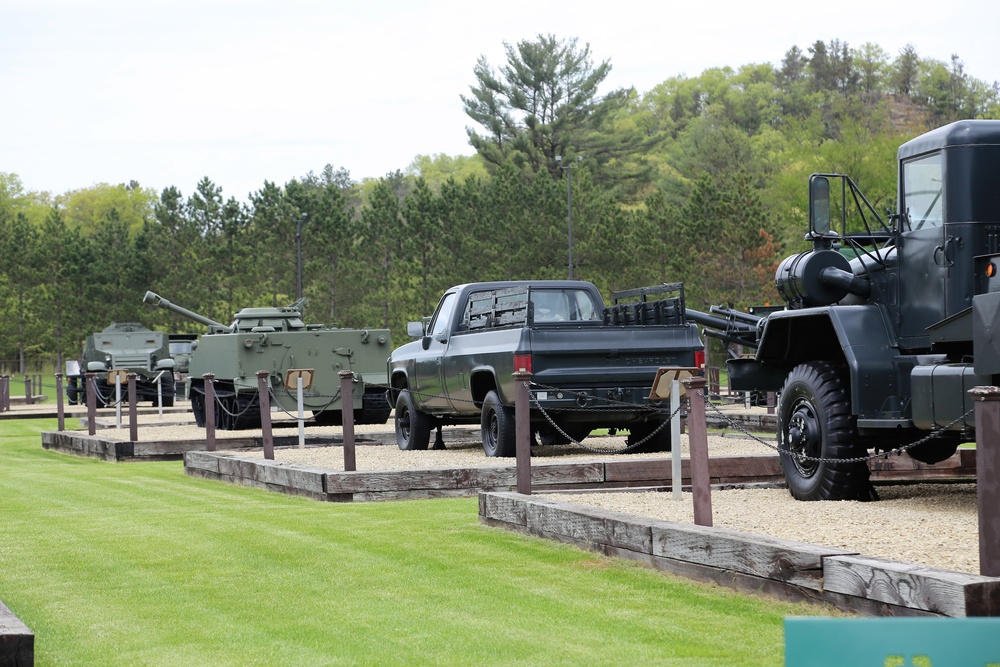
[66,322,175,407]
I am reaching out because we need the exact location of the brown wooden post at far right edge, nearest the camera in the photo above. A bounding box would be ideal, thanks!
[969,387,1000,577]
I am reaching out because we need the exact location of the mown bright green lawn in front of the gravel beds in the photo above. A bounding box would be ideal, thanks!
[0,420,822,666]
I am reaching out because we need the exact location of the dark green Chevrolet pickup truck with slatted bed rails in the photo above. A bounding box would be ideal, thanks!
[387,280,705,456]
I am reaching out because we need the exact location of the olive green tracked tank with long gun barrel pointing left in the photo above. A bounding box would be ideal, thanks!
[143,292,392,430]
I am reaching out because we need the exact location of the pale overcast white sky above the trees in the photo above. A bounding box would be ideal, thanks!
[0,0,1000,201]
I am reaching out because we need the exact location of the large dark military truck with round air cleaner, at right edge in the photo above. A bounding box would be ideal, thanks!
[689,120,1000,500]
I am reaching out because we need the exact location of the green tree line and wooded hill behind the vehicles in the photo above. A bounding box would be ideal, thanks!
[0,35,1000,372]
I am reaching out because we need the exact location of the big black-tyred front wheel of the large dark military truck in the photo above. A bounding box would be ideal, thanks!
[778,362,873,500]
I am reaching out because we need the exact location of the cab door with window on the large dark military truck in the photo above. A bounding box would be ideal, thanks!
[896,151,951,349]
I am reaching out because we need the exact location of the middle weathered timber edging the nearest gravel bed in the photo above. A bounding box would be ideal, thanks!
[651,521,855,590]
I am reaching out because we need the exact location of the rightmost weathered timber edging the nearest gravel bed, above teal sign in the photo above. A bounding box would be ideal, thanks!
[823,556,1000,617]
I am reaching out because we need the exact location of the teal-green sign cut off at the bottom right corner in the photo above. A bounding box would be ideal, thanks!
[785,617,1000,667]
